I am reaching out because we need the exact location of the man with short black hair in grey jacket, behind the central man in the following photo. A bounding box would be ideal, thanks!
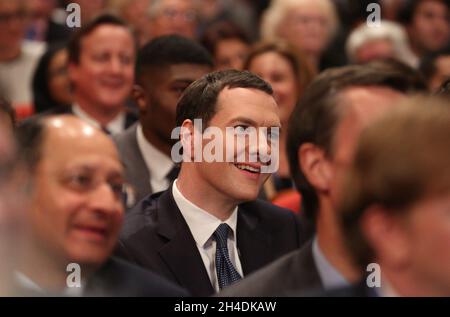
[114,35,213,202]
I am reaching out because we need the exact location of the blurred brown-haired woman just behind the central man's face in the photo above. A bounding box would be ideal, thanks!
[244,41,313,207]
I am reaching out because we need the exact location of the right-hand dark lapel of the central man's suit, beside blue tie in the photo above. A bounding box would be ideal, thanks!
[236,206,272,275]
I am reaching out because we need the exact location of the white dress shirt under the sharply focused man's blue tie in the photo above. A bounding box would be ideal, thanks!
[172,180,244,292]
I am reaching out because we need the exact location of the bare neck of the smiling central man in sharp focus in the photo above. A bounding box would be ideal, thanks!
[177,167,237,221]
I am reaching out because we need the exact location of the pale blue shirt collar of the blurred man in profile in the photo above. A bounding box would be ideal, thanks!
[312,236,350,289]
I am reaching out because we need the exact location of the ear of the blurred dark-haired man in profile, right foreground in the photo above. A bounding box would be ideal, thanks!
[297,143,332,191]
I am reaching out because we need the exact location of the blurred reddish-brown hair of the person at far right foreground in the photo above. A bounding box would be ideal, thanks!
[338,96,450,268]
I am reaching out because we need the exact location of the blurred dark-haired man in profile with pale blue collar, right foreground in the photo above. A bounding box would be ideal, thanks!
[221,62,424,296]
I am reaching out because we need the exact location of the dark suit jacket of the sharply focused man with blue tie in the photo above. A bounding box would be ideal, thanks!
[117,187,310,296]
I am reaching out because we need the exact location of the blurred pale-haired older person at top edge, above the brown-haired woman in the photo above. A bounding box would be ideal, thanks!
[261,0,338,69]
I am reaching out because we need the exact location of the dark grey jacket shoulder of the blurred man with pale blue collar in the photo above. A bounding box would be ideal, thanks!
[218,240,324,297]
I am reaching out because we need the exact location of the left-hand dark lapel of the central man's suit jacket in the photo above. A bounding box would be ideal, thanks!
[158,185,214,296]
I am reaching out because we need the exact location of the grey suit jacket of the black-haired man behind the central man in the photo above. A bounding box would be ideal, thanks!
[113,123,152,203]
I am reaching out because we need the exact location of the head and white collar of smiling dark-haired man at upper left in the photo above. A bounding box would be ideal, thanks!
[56,15,137,134]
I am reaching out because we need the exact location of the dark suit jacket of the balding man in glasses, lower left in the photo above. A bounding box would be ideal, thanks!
[84,257,188,297]
